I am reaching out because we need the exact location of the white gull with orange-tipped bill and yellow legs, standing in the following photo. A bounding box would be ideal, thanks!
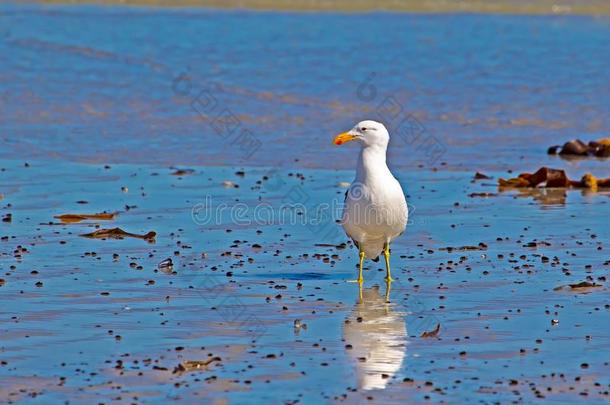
[333,120,409,284]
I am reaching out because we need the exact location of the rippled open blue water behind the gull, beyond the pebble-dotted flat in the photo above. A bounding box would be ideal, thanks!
[0,5,610,174]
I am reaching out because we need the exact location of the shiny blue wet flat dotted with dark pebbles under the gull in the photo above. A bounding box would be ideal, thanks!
[0,161,610,403]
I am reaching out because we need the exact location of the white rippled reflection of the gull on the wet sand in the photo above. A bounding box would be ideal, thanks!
[343,283,407,390]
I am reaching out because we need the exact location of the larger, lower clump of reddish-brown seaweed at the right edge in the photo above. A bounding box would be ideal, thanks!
[498,167,610,190]
